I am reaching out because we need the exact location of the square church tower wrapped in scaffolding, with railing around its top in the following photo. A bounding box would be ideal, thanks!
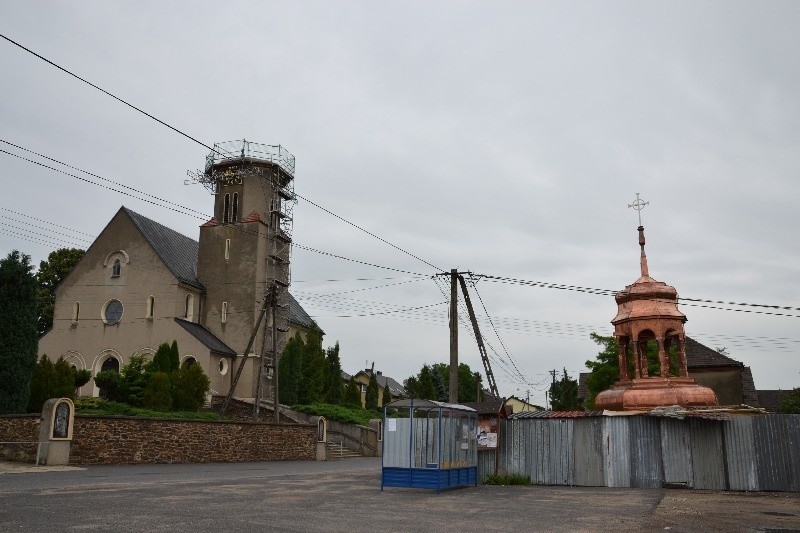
[191,140,296,399]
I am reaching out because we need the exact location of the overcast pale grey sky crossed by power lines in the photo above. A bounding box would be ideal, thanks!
[0,0,800,404]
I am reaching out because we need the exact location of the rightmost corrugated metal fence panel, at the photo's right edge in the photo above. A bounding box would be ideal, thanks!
[753,415,798,490]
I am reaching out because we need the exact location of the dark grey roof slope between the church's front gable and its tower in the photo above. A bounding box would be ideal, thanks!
[122,206,205,290]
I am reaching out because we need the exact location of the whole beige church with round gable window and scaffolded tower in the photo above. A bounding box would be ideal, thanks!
[39,141,322,398]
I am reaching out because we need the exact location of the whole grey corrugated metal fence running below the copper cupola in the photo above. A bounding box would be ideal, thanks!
[488,415,800,491]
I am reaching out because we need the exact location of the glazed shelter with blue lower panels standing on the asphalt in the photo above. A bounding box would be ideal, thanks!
[381,399,478,491]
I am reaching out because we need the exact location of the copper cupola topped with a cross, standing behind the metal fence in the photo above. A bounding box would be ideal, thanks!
[595,193,718,411]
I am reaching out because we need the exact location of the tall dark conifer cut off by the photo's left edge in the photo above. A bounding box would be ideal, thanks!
[0,250,39,414]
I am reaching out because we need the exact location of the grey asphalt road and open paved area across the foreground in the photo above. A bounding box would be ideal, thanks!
[0,458,800,532]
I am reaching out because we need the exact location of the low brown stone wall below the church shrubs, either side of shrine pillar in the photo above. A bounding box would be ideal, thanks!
[0,415,316,465]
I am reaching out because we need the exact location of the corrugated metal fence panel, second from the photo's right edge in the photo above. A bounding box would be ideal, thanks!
[722,416,759,490]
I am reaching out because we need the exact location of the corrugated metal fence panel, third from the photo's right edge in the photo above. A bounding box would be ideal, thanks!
[688,418,726,490]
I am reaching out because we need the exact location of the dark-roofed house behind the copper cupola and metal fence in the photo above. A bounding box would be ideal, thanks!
[578,336,760,407]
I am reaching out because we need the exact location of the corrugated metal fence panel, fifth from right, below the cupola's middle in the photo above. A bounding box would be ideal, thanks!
[628,416,664,488]
